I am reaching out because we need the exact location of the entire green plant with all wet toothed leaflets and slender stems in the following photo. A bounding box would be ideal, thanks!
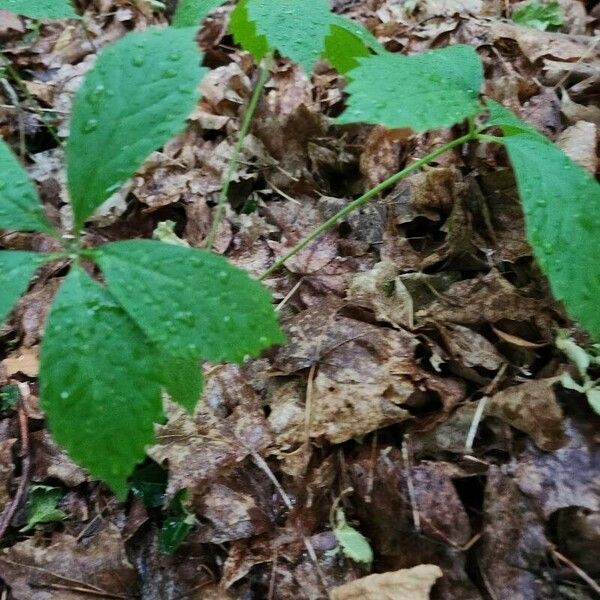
[0,0,600,498]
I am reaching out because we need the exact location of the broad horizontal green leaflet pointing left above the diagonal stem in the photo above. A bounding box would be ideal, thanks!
[337,45,483,131]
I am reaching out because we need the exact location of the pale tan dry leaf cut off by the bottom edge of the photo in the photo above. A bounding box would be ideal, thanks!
[329,565,443,600]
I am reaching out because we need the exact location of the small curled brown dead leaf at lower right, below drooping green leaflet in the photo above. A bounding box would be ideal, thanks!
[484,377,566,452]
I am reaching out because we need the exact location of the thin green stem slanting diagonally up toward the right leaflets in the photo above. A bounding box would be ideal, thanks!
[260,131,478,281]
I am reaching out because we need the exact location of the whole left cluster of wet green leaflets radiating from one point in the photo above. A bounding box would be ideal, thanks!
[0,28,284,498]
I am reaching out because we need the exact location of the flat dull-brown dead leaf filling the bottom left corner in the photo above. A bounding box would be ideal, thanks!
[0,524,137,600]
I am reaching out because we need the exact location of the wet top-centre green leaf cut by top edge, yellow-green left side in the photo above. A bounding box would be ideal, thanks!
[229,0,333,74]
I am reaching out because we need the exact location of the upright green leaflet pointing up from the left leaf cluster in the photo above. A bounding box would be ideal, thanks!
[67,28,205,230]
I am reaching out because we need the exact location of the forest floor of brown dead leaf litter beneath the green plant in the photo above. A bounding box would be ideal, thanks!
[0,0,600,600]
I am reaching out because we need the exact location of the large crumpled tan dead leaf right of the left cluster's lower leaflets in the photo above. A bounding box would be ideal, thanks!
[267,303,463,448]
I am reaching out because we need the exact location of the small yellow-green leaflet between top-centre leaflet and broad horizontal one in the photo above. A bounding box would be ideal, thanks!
[323,15,385,73]
